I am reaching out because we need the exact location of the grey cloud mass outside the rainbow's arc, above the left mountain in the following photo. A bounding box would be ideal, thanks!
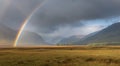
[0,0,43,29]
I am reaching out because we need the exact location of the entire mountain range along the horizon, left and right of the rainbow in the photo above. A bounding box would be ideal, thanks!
[0,22,120,46]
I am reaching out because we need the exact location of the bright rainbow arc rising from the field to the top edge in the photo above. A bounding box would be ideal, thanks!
[13,0,47,47]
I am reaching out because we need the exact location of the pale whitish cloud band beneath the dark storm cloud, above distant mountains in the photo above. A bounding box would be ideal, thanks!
[40,24,105,44]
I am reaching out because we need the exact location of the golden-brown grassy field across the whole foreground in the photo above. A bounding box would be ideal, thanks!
[0,46,120,66]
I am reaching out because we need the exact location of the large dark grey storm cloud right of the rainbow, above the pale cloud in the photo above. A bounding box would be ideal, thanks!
[27,0,120,30]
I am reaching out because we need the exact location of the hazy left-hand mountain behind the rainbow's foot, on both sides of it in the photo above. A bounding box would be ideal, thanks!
[0,24,47,46]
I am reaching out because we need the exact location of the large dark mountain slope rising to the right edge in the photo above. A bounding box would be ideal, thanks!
[75,22,120,44]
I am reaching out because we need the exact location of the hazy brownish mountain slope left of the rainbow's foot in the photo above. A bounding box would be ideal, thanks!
[0,23,17,44]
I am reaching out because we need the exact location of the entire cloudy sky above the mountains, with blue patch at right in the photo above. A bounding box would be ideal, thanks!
[0,0,120,43]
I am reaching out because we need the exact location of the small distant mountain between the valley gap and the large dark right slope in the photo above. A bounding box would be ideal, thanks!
[58,35,84,44]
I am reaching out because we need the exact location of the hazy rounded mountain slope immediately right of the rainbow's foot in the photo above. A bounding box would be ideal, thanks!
[18,31,48,45]
